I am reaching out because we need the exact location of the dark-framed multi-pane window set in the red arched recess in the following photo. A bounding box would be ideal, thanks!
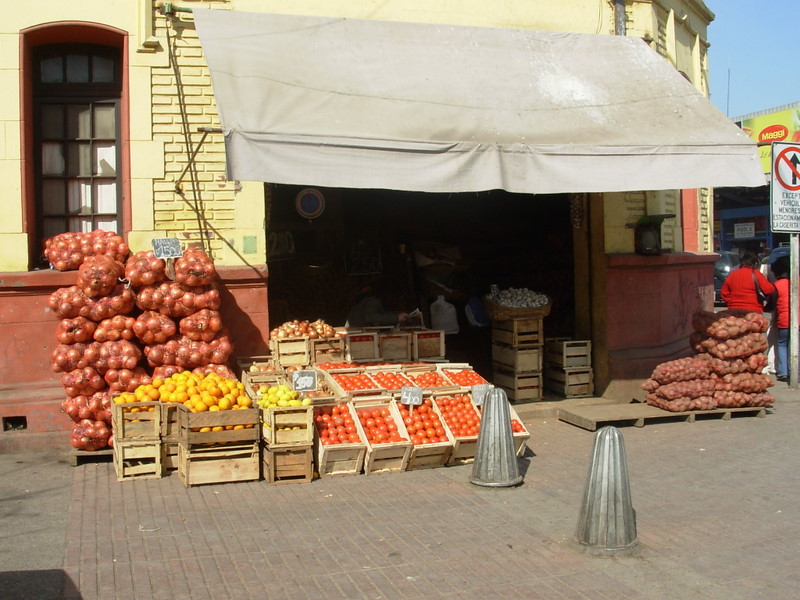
[33,44,121,262]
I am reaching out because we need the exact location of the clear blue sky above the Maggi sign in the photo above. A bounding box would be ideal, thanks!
[705,0,800,117]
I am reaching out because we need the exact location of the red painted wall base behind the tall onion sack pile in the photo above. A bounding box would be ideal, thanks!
[0,265,269,452]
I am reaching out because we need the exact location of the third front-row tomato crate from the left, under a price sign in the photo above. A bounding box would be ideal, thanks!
[397,396,455,471]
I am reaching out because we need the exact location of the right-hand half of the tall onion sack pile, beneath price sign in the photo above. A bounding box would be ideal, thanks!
[131,248,235,379]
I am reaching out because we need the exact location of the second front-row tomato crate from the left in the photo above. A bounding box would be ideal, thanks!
[352,396,411,474]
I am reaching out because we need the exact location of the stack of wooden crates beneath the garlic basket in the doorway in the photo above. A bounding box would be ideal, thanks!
[492,317,544,401]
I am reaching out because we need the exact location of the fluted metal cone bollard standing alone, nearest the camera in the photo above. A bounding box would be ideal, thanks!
[575,426,639,554]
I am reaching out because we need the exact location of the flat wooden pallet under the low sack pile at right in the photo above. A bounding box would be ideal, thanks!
[558,402,767,431]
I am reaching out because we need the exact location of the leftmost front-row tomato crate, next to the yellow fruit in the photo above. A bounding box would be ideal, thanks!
[314,402,367,477]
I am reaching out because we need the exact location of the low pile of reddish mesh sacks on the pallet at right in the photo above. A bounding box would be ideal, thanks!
[642,310,775,412]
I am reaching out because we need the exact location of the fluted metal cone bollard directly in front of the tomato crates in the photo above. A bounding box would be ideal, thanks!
[469,388,522,487]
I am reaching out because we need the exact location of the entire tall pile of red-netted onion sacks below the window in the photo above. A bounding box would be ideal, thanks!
[45,230,233,450]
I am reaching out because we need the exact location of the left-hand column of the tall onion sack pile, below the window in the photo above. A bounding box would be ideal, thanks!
[45,230,139,450]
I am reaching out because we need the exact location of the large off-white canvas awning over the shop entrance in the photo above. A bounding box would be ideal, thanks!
[194,9,765,193]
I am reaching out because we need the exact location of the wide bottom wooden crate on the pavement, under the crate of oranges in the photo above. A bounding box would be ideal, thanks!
[178,440,261,487]
